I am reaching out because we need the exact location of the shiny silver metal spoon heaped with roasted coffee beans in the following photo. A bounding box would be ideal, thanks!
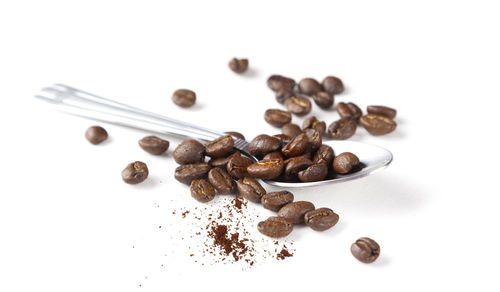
[35,84,392,188]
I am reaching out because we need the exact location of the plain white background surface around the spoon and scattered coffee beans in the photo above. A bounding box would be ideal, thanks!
[0,1,500,291]
